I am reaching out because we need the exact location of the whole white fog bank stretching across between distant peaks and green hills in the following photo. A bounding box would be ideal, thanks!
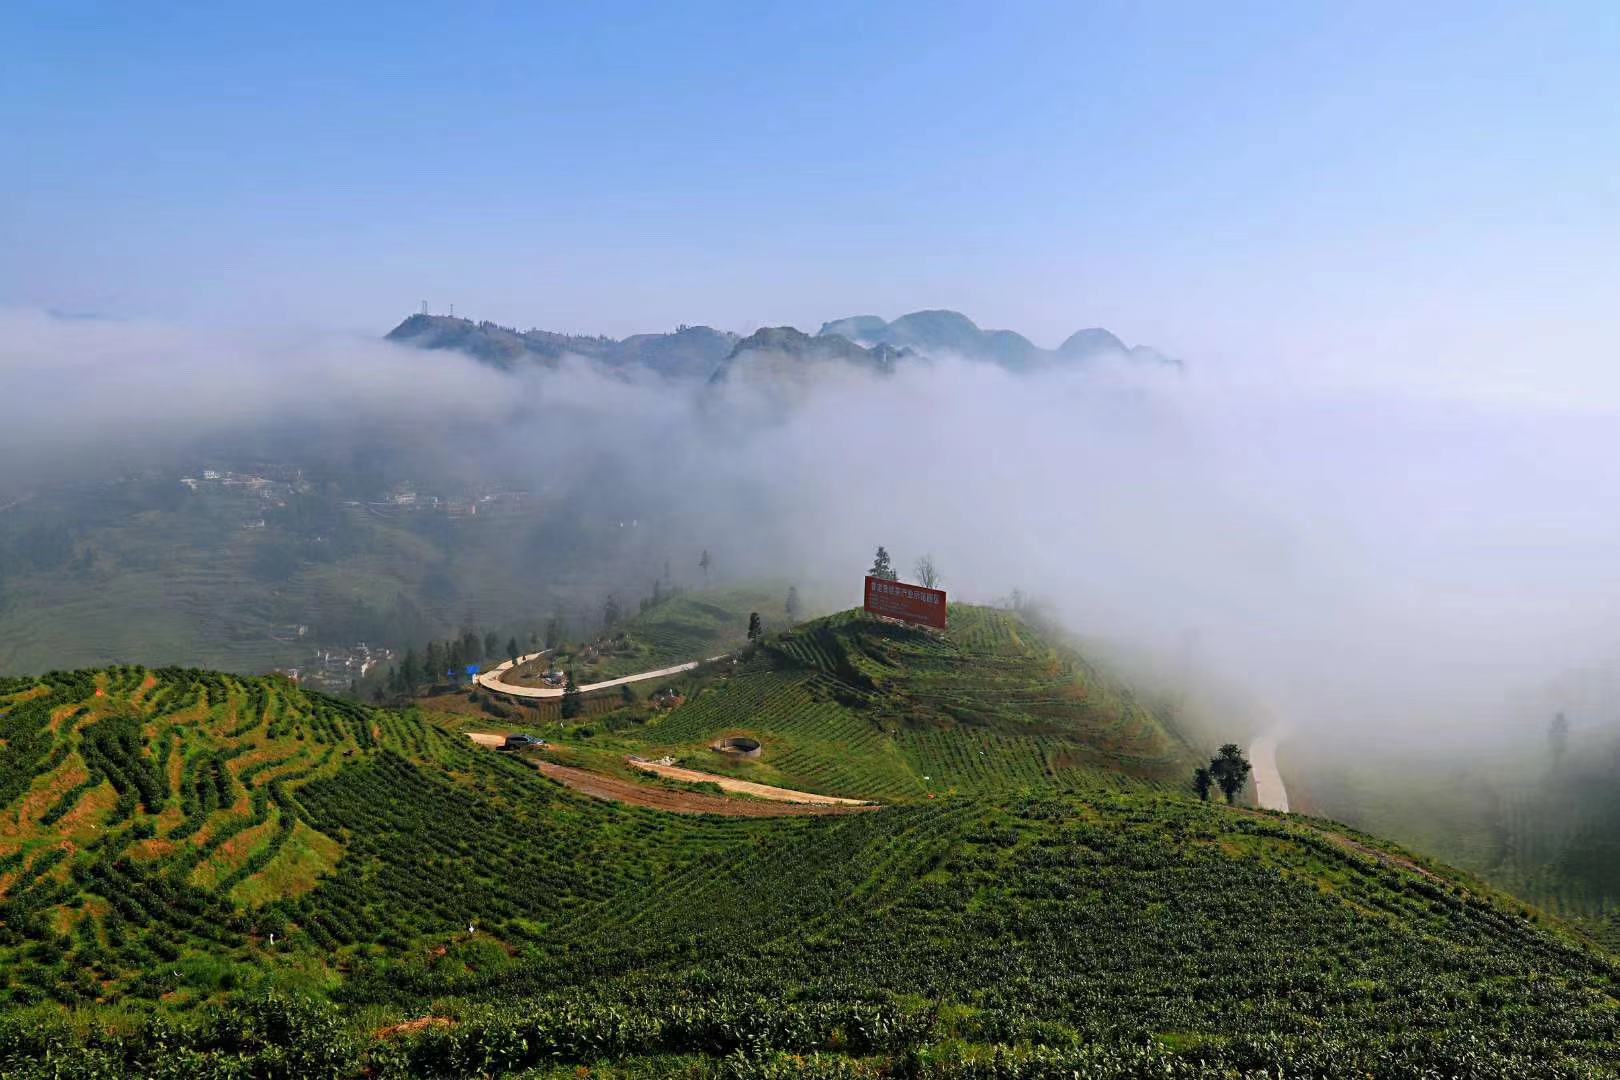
[0,311,1620,746]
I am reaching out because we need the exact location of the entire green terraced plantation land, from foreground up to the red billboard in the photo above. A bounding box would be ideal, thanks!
[0,597,1620,1077]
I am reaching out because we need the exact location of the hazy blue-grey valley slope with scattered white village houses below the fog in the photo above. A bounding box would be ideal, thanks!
[0,466,673,674]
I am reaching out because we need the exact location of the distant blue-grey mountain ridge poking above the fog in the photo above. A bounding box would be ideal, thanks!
[387,311,1181,384]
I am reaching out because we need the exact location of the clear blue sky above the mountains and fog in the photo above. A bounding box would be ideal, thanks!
[0,2,1620,389]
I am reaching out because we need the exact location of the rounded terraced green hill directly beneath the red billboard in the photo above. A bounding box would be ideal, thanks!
[592,604,1197,801]
